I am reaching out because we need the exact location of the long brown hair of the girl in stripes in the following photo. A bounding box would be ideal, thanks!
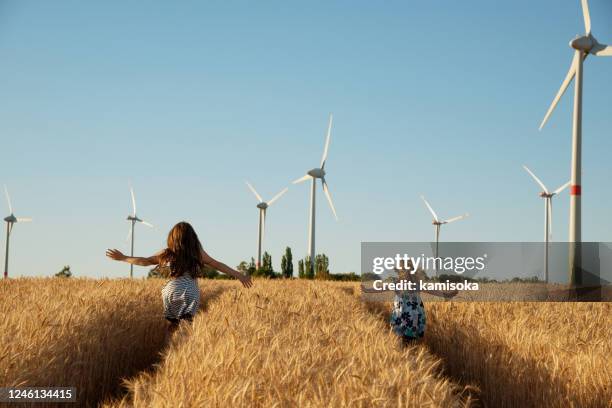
[159,221,204,278]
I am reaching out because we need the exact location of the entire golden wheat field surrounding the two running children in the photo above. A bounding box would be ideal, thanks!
[0,279,612,407]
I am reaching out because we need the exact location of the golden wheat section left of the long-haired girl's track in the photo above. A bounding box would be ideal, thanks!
[0,279,228,406]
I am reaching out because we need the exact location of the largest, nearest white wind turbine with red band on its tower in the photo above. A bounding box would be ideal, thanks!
[540,0,612,286]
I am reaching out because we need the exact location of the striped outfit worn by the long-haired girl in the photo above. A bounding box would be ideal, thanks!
[162,273,200,320]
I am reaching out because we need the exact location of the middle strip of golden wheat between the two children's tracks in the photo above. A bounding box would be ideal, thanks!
[106,281,466,407]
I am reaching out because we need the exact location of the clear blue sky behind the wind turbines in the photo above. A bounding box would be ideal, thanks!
[0,0,612,277]
